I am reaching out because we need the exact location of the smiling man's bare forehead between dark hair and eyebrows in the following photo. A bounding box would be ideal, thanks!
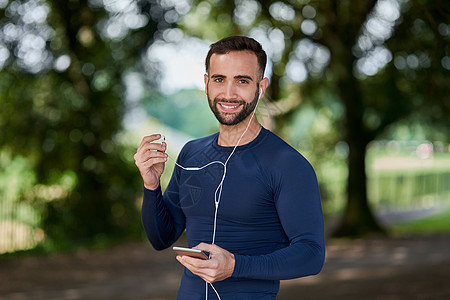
[209,51,258,77]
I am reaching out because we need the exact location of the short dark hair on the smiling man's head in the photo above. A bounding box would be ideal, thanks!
[205,36,267,79]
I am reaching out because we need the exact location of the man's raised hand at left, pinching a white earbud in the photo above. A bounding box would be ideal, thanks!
[134,134,167,190]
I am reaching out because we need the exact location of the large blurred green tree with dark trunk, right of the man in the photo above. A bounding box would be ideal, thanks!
[180,0,450,236]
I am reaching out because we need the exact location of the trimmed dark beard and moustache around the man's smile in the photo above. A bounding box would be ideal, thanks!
[208,89,259,126]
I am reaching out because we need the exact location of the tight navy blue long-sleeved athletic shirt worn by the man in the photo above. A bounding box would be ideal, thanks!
[142,128,325,300]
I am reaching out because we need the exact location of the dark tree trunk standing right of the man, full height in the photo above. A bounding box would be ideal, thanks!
[328,1,384,237]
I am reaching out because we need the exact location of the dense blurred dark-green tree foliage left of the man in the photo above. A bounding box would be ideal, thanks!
[0,0,178,244]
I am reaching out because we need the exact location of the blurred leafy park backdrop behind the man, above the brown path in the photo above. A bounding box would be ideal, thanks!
[0,0,450,298]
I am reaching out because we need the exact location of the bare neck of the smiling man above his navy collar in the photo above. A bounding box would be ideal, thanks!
[217,116,261,147]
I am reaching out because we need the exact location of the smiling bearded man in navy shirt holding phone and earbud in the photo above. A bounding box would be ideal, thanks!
[135,37,325,300]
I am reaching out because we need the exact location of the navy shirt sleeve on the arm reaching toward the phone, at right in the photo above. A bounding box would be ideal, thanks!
[232,157,325,280]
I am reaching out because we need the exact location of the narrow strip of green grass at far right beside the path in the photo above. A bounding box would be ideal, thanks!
[390,209,450,235]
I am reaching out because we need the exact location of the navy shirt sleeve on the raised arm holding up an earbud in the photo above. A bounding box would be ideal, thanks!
[141,164,186,250]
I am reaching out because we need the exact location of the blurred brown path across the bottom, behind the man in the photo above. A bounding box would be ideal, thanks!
[0,235,450,300]
